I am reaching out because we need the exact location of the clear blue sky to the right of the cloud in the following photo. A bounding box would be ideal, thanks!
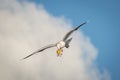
[26,0,120,80]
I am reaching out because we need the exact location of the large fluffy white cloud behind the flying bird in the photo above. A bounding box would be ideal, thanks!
[0,0,110,80]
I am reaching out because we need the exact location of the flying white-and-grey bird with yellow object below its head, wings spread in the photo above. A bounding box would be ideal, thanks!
[23,22,87,59]
